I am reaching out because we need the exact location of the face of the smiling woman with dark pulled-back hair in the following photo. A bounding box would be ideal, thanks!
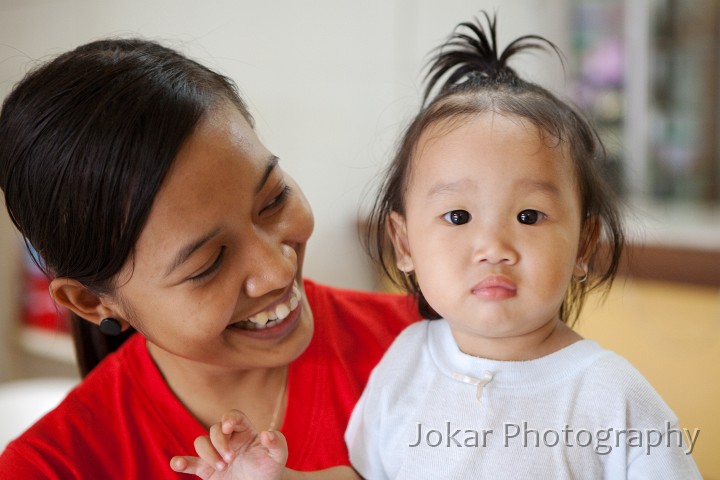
[111,103,313,394]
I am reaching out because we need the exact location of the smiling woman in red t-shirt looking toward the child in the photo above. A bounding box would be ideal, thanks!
[0,39,417,478]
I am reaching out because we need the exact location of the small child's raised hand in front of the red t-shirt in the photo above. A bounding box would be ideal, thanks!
[170,410,287,480]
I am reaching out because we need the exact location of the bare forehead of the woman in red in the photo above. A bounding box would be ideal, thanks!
[131,106,268,262]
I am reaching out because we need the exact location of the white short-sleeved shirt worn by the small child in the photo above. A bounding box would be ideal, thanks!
[345,320,702,480]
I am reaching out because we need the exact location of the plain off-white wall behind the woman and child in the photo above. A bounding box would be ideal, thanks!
[0,0,568,377]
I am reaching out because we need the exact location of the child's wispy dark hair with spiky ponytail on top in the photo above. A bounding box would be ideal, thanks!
[365,12,624,324]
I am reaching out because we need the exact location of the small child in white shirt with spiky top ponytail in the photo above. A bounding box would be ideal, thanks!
[173,11,701,480]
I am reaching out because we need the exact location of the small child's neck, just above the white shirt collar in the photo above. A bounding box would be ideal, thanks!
[451,320,582,361]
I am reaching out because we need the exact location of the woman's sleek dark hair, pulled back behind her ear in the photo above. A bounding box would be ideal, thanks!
[0,39,252,376]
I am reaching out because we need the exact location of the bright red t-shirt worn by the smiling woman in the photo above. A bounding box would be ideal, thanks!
[0,280,418,479]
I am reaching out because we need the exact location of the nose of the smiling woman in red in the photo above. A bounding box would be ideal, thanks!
[244,238,298,297]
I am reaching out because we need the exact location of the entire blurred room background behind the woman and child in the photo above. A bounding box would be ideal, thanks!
[0,0,720,479]
